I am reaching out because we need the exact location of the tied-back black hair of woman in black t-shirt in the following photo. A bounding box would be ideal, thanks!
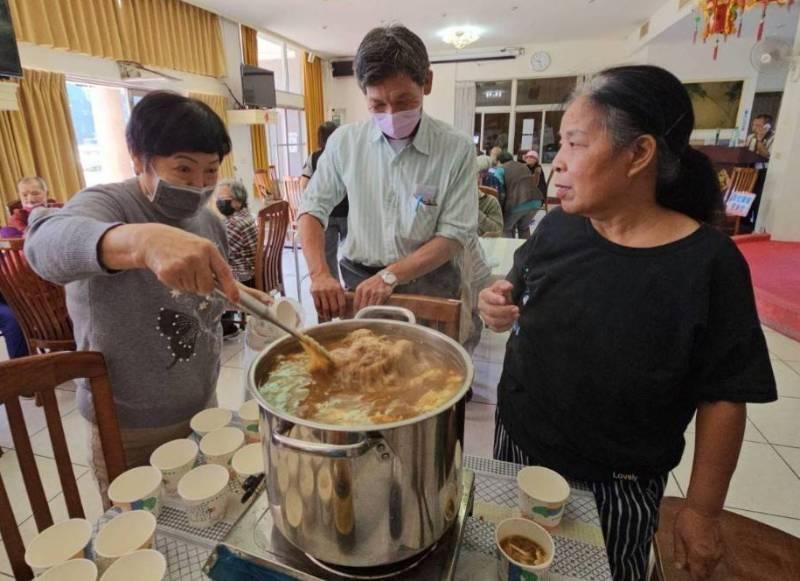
[574,65,723,223]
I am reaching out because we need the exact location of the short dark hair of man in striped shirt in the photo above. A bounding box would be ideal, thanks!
[353,24,430,91]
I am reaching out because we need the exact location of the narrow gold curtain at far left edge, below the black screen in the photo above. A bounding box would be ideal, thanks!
[0,102,36,225]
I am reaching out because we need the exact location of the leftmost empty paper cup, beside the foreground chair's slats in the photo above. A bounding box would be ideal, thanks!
[25,518,92,575]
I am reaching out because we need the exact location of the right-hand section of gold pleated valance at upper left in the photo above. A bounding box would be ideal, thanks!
[120,0,226,77]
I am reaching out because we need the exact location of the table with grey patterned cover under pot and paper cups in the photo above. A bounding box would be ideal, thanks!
[98,456,611,581]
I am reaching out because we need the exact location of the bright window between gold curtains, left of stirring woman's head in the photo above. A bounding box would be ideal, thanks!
[67,82,135,186]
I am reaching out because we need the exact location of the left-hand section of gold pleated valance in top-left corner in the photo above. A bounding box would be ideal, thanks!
[9,0,126,60]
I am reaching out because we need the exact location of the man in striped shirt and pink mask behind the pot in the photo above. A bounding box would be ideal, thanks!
[299,25,478,317]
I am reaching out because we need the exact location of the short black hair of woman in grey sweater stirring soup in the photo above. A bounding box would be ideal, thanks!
[125,91,231,161]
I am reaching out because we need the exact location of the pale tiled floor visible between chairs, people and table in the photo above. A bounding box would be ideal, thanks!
[0,251,800,579]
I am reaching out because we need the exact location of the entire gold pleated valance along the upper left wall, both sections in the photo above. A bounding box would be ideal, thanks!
[10,0,226,77]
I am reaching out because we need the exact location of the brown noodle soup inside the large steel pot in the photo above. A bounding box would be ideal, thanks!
[259,329,464,426]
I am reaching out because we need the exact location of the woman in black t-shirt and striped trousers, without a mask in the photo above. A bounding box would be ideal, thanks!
[480,66,776,581]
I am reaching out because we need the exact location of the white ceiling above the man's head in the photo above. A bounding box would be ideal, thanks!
[188,0,665,57]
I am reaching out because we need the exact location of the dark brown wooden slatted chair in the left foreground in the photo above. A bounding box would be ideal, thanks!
[0,351,126,580]
